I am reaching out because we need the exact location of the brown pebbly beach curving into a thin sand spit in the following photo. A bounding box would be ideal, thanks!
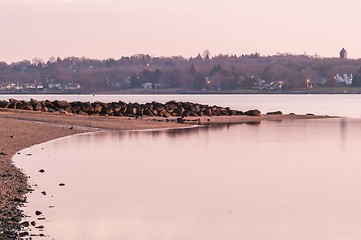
[0,109,332,239]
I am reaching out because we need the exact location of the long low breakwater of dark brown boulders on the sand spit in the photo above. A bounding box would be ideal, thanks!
[0,99,261,118]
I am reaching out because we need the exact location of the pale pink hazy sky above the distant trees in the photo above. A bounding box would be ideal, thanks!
[0,0,361,63]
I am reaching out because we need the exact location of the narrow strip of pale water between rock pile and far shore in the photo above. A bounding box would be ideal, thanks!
[0,94,361,117]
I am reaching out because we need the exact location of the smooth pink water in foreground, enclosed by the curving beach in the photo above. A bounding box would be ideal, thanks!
[14,119,361,240]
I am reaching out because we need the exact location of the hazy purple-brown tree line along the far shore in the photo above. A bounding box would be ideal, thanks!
[0,52,361,92]
